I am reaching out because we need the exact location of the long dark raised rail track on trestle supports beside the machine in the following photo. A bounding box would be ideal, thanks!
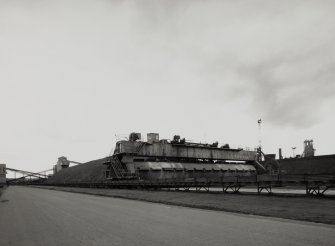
[25,174,335,196]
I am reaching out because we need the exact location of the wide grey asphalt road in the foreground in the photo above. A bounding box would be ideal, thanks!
[0,187,335,246]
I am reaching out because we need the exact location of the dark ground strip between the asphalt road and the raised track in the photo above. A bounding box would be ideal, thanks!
[30,186,335,224]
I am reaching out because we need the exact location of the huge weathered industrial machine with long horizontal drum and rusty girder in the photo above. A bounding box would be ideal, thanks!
[104,133,263,180]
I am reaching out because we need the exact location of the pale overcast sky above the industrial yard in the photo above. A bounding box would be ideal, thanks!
[0,0,335,171]
